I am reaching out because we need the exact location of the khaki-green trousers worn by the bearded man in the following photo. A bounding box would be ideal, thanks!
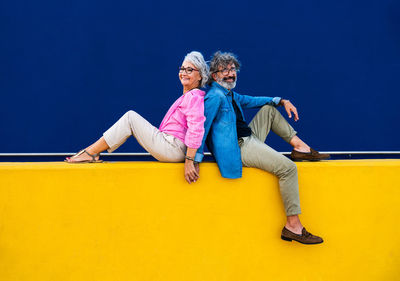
[239,105,301,216]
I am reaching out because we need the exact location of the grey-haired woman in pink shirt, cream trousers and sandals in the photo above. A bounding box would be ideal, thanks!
[65,52,208,183]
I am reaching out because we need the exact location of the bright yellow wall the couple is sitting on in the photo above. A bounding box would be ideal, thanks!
[0,160,400,281]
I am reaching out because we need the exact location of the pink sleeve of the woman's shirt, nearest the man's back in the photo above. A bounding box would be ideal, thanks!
[181,90,206,148]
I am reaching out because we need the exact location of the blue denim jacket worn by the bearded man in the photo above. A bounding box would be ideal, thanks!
[195,82,281,179]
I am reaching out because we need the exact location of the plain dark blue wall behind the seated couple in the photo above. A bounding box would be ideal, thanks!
[0,0,400,152]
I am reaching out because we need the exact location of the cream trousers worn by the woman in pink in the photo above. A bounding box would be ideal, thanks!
[103,110,186,162]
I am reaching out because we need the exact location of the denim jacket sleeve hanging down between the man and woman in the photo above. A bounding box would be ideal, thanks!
[194,92,221,162]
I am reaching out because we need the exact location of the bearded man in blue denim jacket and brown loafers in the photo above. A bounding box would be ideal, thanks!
[194,52,329,244]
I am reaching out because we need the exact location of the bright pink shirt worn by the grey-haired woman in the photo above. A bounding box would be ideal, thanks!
[159,89,206,148]
